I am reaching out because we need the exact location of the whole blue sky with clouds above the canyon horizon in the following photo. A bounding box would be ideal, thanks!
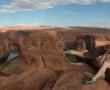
[0,0,110,28]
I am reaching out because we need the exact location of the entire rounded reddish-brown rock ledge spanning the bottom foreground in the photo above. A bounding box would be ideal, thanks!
[0,64,110,90]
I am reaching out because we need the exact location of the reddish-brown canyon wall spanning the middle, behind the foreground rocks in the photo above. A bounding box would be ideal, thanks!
[0,28,110,69]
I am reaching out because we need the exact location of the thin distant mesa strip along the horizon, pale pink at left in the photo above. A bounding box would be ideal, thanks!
[0,24,110,32]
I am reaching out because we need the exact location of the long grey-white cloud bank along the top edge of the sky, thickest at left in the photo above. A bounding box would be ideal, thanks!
[0,0,110,13]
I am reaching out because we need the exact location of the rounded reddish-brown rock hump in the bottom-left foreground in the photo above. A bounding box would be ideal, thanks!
[0,68,57,90]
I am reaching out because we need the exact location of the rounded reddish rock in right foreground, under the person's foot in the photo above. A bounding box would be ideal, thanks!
[52,64,110,90]
